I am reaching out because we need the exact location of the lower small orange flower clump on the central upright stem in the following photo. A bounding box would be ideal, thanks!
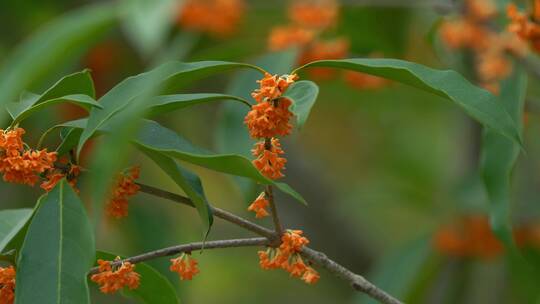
[252,137,287,179]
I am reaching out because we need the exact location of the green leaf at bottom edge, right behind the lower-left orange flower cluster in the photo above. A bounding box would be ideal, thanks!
[96,251,180,304]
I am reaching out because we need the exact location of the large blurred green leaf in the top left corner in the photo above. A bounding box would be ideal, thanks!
[0,2,116,122]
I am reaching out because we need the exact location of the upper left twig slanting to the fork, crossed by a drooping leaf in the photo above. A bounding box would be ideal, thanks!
[137,183,275,240]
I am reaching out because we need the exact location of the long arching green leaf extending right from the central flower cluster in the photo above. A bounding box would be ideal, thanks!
[296,58,521,144]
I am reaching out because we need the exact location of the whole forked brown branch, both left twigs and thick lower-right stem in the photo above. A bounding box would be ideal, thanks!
[137,184,402,304]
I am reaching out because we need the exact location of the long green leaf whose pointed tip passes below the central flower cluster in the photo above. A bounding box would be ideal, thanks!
[61,119,306,204]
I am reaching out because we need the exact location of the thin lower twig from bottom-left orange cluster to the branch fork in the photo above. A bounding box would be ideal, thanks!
[89,237,269,274]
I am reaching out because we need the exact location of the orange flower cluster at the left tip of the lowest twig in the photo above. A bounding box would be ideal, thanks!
[90,257,140,293]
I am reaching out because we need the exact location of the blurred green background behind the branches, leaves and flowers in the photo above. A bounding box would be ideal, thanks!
[0,0,540,304]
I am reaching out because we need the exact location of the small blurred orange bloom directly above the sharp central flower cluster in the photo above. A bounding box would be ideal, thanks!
[268,25,315,51]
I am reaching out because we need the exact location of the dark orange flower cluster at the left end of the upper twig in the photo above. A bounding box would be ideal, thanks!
[106,166,140,219]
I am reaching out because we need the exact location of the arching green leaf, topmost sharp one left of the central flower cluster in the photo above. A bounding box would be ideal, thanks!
[77,61,264,154]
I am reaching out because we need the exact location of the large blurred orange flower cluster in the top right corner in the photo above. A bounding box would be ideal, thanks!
[440,0,527,94]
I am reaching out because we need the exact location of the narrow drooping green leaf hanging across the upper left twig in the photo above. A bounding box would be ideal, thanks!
[139,146,214,233]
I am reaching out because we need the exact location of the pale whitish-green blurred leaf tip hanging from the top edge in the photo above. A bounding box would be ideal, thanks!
[121,0,178,59]
